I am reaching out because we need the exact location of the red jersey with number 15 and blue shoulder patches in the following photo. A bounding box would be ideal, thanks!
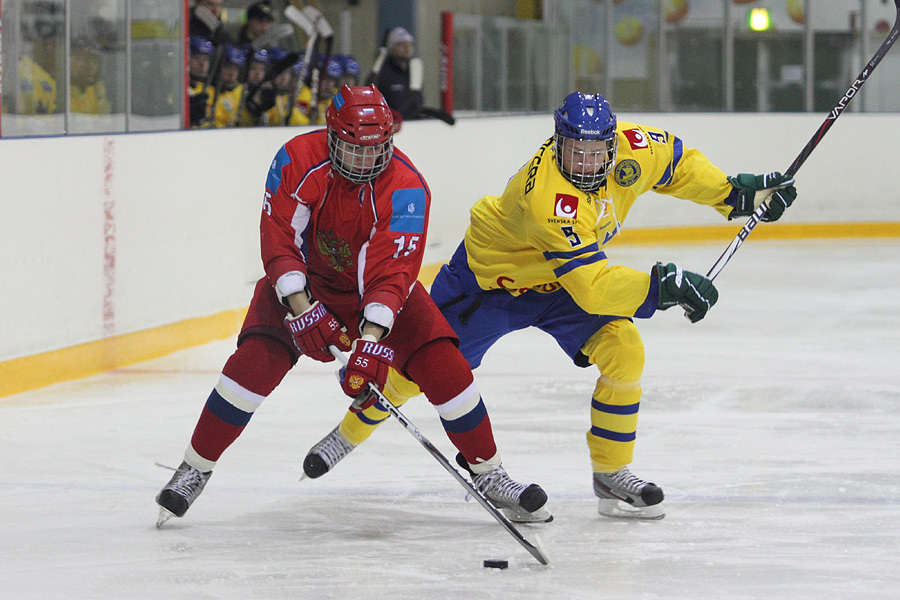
[260,129,431,325]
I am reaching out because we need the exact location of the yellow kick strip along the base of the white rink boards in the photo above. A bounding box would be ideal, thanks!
[0,221,900,398]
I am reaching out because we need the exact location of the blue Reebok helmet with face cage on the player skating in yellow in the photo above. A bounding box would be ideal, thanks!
[553,92,618,192]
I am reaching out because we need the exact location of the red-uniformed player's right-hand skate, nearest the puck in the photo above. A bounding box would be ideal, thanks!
[456,454,553,523]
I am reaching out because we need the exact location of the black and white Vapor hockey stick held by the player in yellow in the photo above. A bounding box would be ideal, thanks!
[706,0,900,279]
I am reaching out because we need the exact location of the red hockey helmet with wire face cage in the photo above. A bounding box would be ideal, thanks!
[325,85,394,183]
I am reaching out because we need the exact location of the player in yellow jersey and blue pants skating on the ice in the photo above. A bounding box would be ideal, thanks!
[304,92,797,519]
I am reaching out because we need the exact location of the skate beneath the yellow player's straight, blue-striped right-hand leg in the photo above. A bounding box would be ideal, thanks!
[593,467,666,519]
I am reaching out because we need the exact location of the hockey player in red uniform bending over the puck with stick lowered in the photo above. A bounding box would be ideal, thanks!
[156,85,551,526]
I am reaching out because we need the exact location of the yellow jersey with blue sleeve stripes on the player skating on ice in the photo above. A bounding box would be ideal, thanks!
[465,121,732,317]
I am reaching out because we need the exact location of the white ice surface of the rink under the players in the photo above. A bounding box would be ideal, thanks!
[0,239,900,600]
